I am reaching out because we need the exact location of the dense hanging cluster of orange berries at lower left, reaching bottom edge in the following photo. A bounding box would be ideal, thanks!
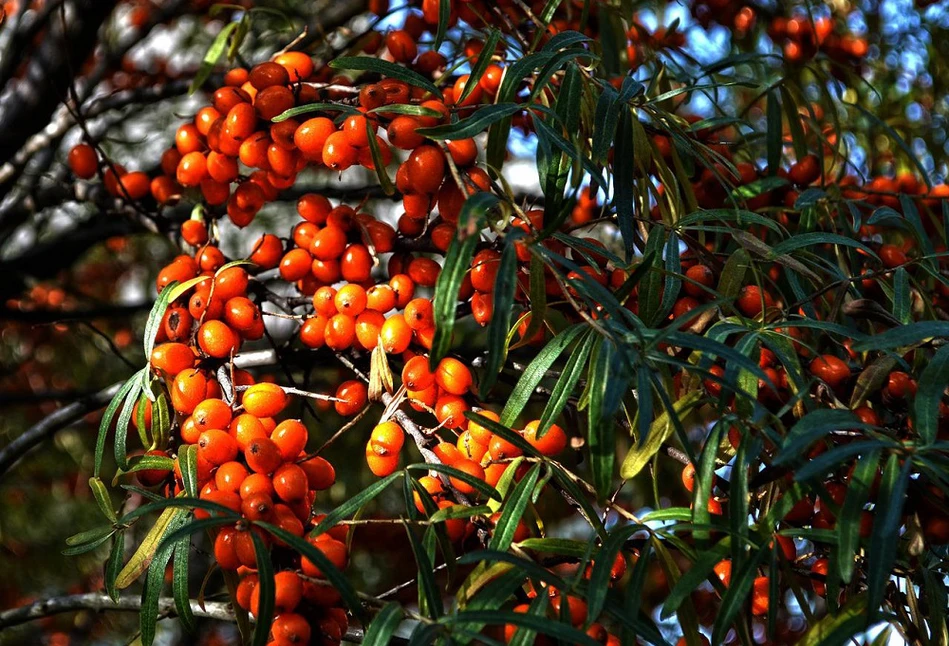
[144,352,356,646]
